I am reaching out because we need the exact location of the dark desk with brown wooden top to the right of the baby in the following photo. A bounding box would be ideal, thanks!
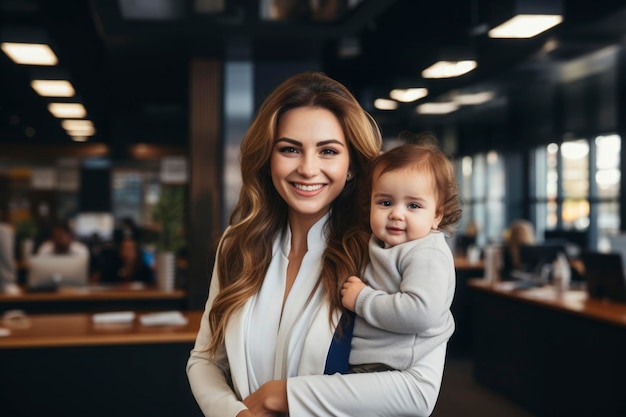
[469,280,626,417]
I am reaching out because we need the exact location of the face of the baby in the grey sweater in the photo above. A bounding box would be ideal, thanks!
[370,169,441,246]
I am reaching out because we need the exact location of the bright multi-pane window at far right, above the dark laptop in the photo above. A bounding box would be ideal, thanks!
[531,134,621,249]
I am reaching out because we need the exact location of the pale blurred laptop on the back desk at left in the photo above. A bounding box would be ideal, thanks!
[26,255,89,291]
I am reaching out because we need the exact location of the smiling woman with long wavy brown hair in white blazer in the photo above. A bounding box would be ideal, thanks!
[187,73,445,417]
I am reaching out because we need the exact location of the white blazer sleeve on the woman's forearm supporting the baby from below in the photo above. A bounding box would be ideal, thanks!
[287,343,446,417]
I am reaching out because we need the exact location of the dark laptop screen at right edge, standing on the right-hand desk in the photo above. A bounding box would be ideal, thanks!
[581,251,626,302]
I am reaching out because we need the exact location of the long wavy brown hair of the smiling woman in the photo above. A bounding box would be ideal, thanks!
[208,72,382,354]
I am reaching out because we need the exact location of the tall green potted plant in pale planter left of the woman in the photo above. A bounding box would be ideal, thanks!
[152,186,187,290]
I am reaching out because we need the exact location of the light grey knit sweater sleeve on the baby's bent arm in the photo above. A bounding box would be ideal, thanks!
[356,247,455,334]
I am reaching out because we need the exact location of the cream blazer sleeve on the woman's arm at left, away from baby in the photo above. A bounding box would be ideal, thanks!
[187,255,247,417]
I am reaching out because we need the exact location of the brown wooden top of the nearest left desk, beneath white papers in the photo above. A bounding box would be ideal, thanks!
[0,311,202,349]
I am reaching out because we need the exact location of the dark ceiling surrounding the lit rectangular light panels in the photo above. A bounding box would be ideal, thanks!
[0,0,626,152]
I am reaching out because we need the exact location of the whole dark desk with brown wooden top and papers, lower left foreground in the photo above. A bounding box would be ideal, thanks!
[0,311,202,417]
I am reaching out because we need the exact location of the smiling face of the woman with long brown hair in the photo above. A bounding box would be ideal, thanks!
[270,107,350,224]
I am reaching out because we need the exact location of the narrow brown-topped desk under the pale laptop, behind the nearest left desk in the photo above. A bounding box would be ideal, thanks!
[0,284,187,314]
